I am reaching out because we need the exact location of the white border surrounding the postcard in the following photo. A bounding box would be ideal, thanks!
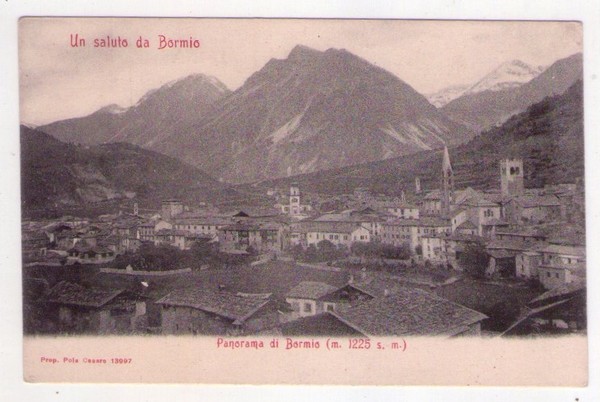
[0,0,600,402]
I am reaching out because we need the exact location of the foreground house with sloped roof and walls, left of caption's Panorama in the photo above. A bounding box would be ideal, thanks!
[156,288,279,336]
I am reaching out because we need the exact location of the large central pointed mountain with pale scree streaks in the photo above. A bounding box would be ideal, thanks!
[153,46,473,183]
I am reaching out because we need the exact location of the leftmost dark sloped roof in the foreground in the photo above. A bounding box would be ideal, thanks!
[44,281,123,308]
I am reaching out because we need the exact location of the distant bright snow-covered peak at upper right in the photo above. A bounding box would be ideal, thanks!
[464,60,545,95]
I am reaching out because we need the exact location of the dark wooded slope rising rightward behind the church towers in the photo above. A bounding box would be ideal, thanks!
[241,80,584,195]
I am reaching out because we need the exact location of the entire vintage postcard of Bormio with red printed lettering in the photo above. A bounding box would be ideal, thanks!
[18,17,588,387]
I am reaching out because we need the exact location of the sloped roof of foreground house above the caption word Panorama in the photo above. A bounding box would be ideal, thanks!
[156,288,269,322]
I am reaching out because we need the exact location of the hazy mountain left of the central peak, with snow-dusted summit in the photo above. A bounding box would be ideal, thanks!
[39,74,230,149]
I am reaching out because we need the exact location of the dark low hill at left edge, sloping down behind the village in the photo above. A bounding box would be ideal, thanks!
[21,126,237,218]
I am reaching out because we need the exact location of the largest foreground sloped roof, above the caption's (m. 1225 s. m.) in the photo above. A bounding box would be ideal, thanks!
[330,288,487,336]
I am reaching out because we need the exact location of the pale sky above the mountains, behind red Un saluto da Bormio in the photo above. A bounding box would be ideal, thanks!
[19,18,582,125]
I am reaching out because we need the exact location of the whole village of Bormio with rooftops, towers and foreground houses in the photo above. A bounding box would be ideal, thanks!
[22,148,586,337]
